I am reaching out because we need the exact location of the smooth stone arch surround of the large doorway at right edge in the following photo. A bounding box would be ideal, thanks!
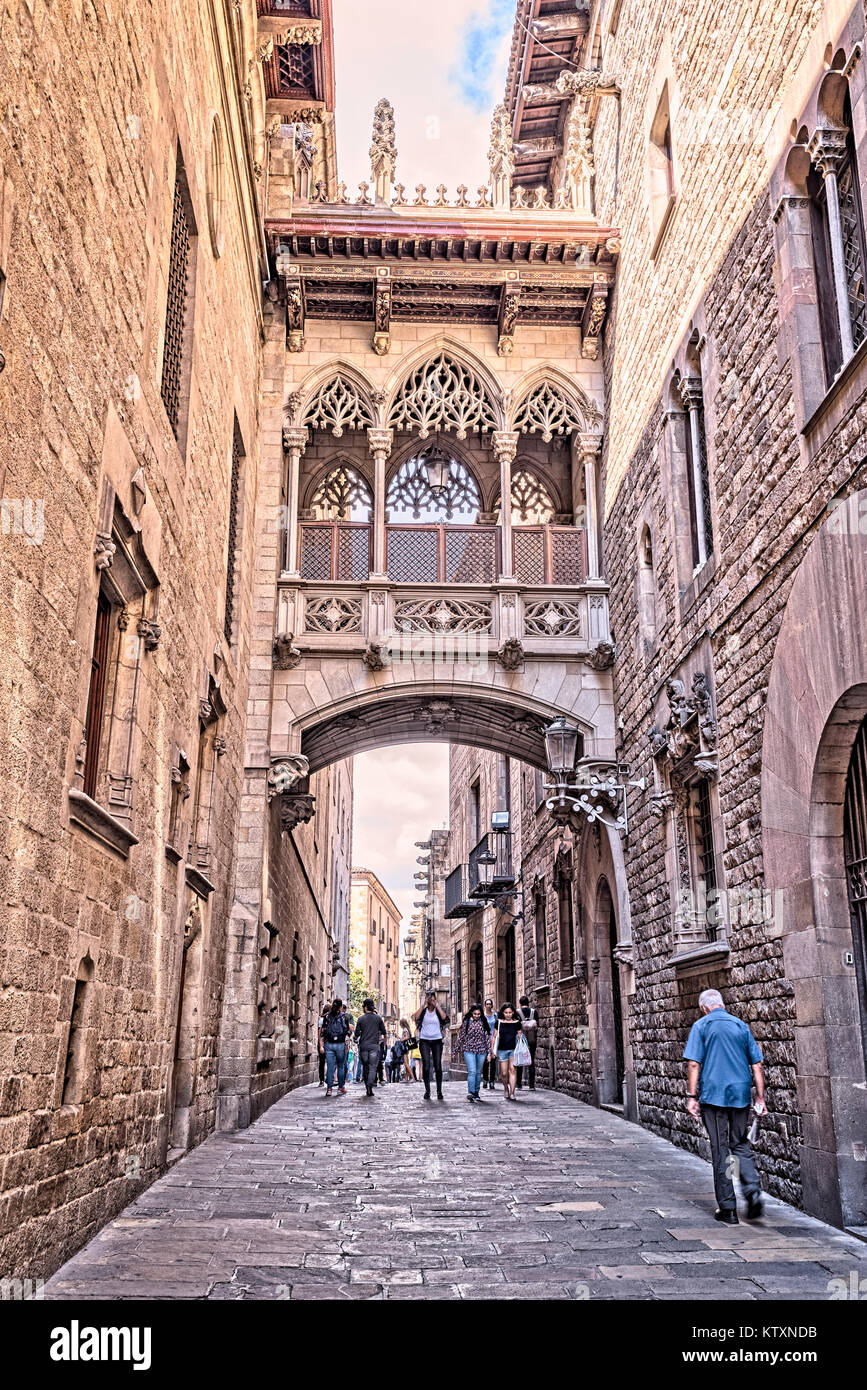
[761,492,867,1226]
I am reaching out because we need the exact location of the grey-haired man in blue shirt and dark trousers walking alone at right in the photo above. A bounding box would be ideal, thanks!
[684,990,766,1226]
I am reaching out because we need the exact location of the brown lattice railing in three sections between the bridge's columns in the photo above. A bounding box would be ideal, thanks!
[299,521,586,587]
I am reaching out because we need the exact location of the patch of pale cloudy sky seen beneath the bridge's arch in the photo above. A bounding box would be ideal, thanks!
[353,744,449,931]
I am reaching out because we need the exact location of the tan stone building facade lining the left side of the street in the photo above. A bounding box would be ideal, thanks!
[0,3,352,1275]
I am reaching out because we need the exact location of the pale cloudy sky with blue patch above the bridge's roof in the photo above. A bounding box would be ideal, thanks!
[333,0,513,197]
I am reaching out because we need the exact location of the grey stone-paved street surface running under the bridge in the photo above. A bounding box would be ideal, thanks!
[46,1083,867,1300]
